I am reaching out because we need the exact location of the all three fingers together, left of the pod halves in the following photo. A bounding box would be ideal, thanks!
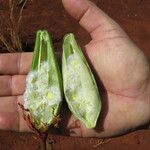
[0,53,32,131]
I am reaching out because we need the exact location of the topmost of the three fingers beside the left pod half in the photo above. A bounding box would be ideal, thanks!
[0,53,32,75]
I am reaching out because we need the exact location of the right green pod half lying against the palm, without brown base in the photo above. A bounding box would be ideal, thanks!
[62,33,101,128]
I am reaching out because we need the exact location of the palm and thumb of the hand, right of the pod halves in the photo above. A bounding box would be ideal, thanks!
[62,0,150,137]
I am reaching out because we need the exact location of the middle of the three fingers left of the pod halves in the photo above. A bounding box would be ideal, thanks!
[0,75,26,96]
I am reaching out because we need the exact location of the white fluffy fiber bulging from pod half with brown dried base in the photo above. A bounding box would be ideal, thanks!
[24,62,61,119]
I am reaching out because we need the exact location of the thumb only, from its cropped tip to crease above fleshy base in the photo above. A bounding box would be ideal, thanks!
[62,0,126,40]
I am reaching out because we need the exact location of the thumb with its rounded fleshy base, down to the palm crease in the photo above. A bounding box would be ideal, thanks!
[62,0,149,96]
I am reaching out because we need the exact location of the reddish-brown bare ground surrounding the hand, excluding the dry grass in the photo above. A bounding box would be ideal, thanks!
[0,0,150,150]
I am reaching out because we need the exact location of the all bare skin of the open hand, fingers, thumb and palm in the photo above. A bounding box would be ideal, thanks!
[0,0,150,137]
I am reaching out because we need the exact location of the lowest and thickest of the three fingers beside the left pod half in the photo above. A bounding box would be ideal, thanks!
[0,96,31,131]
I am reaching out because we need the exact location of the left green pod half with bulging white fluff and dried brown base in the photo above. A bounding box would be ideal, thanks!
[24,30,62,132]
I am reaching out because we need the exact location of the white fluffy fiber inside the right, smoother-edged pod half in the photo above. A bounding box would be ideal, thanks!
[65,53,94,116]
